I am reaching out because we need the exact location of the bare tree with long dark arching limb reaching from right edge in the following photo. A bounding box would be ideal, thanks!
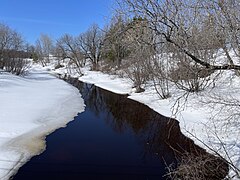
[119,0,240,70]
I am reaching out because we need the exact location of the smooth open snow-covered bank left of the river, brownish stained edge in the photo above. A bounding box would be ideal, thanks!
[0,68,84,180]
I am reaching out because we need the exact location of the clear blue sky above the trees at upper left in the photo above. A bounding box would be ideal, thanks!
[0,0,114,44]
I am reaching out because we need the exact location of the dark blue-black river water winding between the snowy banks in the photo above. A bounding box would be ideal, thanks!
[13,79,228,180]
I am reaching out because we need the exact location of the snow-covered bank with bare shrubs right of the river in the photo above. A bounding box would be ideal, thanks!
[54,64,240,179]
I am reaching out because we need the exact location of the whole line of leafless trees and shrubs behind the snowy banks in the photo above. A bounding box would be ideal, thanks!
[0,0,240,94]
